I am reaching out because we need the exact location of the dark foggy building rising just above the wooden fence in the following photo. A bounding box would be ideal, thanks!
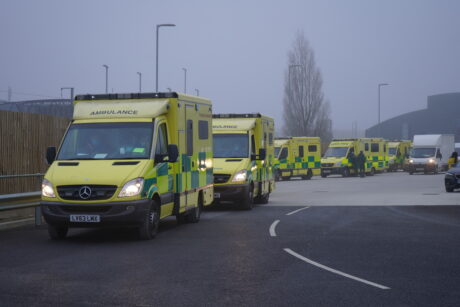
[0,99,73,118]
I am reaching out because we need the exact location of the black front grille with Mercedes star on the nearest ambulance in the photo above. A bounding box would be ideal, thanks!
[57,185,117,201]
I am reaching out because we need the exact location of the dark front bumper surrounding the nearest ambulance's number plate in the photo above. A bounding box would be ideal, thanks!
[40,199,152,227]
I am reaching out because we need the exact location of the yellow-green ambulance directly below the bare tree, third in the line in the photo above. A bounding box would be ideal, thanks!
[275,137,321,180]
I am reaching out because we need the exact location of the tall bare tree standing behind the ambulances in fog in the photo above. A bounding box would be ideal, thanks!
[283,32,332,142]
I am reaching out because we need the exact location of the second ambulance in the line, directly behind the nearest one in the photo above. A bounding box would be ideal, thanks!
[212,113,275,210]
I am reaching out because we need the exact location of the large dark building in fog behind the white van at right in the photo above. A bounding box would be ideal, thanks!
[366,93,460,142]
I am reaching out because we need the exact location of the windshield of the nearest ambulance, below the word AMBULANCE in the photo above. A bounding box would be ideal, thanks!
[57,122,153,160]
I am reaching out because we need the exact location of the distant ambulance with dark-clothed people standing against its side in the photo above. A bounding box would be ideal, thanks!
[321,138,388,178]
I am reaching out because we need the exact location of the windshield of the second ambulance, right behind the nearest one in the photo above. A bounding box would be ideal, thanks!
[213,133,249,158]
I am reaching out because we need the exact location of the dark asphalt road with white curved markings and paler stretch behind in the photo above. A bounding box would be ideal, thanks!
[0,173,460,306]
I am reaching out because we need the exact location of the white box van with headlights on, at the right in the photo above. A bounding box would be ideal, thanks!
[408,134,455,175]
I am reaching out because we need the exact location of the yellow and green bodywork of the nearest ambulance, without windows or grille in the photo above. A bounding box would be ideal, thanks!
[42,93,213,218]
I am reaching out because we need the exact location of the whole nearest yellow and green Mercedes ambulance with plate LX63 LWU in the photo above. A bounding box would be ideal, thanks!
[41,92,214,239]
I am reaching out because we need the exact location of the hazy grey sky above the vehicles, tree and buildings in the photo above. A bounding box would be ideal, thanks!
[0,0,460,135]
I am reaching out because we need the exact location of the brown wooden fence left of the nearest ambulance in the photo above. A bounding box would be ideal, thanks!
[0,111,69,195]
